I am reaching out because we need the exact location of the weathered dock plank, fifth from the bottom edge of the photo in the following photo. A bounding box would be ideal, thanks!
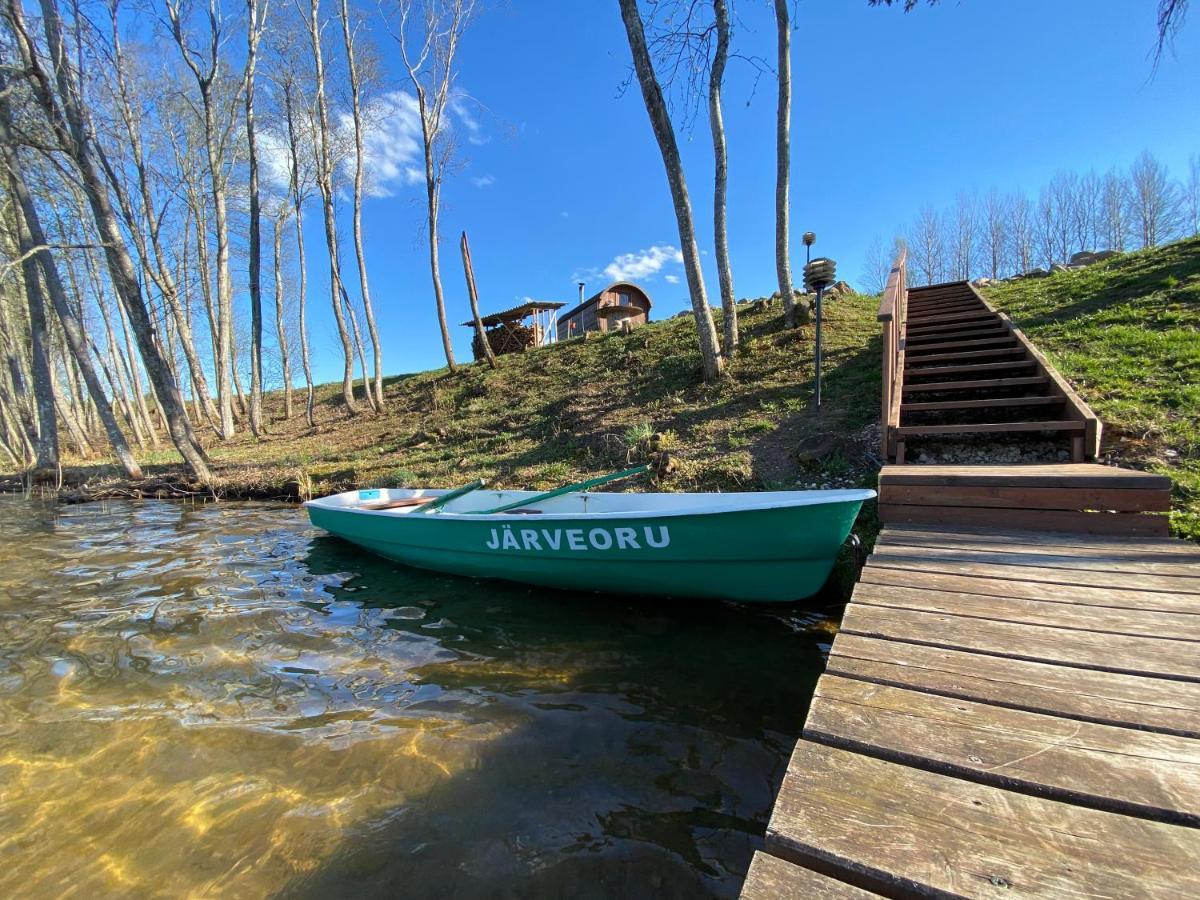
[841,604,1200,682]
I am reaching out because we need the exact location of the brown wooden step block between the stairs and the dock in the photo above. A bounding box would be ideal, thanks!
[880,463,1171,538]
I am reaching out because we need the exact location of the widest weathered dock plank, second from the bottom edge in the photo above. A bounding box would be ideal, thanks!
[767,740,1200,900]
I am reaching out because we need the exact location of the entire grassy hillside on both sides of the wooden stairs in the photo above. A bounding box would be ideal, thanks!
[0,239,1200,540]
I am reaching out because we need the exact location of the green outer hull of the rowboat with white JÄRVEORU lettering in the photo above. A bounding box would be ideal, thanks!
[307,499,863,602]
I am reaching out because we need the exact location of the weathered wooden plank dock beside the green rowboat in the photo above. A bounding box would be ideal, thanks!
[743,525,1200,898]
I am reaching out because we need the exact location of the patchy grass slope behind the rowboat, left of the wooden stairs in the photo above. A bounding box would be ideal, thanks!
[37,295,880,508]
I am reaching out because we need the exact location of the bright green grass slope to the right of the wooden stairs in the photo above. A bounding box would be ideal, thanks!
[984,238,1200,540]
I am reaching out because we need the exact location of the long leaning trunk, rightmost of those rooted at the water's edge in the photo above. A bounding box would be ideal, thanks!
[5,0,212,484]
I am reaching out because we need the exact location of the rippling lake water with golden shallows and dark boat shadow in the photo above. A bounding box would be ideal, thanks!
[0,498,821,896]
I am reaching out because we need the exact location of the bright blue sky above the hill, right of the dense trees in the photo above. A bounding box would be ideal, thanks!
[292,0,1200,380]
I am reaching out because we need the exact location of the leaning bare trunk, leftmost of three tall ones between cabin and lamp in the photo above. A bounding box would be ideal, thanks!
[618,0,724,382]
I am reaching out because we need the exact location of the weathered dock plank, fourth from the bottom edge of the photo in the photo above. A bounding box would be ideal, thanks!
[826,632,1200,738]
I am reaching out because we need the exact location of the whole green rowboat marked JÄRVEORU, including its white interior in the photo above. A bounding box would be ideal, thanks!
[305,485,875,601]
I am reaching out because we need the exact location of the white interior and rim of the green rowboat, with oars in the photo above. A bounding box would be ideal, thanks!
[305,487,875,518]
